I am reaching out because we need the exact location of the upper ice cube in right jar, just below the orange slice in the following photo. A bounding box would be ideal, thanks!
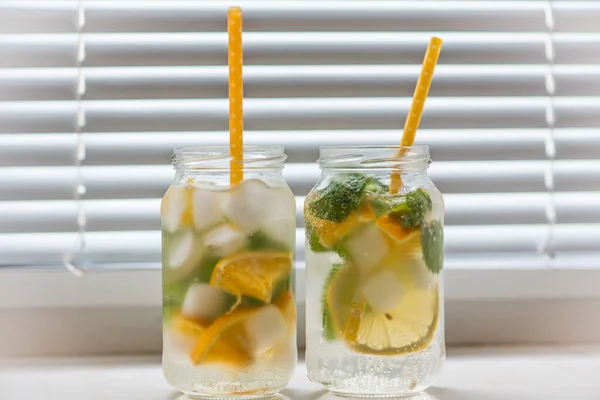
[346,225,390,274]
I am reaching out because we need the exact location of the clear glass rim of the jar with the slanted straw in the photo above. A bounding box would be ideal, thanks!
[318,145,431,169]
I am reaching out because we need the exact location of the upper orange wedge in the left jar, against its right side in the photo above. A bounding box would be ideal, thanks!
[210,251,293,303]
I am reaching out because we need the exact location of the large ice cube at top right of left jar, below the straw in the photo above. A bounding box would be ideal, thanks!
[223,179,296,234]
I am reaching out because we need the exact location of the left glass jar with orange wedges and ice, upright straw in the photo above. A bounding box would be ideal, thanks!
[161,147,297,398]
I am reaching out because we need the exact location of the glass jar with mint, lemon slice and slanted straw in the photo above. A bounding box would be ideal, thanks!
[304,146,445,397]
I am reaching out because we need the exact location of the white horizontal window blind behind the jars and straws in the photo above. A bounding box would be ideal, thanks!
[0,0,600,268]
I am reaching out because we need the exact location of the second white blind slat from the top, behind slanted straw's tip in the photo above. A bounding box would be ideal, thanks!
[5,32,600,67]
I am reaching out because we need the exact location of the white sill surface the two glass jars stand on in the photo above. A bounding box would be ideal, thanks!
[0,347,600,400]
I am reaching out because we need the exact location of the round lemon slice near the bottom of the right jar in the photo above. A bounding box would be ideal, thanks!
[344,285,440,355]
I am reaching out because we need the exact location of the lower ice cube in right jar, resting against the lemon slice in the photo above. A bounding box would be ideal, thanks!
[360,269,405,314]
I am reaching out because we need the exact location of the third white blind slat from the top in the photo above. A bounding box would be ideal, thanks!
[0,65,552,101]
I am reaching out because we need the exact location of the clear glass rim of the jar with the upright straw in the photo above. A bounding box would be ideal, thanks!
[171,146,287,170]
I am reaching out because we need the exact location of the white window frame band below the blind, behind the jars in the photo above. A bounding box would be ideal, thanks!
[0,269,600,356]
